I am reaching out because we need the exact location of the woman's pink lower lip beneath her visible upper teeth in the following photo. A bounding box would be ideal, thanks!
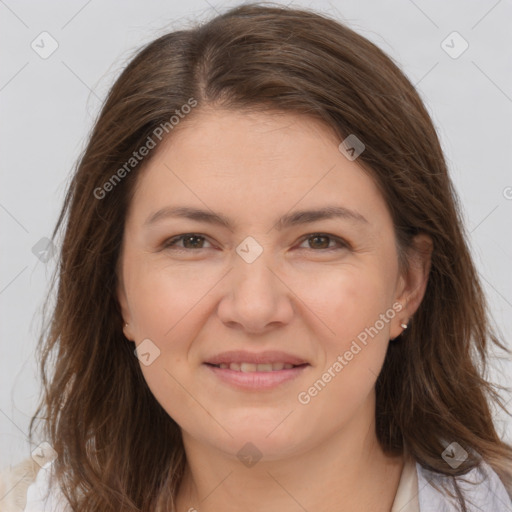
[205,364,309,390]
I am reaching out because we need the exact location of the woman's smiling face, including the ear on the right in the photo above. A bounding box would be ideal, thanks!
[118,110,428,460]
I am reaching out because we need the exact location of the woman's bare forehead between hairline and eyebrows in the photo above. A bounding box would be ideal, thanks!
[126,110,387,232]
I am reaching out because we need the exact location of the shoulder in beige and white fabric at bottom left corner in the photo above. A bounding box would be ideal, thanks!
[0,459,70,512]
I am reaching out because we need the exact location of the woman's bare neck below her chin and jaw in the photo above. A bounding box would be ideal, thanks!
[176,402,404,512]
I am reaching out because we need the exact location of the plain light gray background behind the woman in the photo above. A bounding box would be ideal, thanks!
[0,0,512,467]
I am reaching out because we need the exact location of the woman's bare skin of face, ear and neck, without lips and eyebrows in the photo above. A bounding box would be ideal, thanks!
[118,106,432,512]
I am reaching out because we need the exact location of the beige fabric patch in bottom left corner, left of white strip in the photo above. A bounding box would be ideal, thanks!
[0,458,41,512]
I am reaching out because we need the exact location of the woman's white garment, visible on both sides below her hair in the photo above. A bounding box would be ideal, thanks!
[24,459,512,512]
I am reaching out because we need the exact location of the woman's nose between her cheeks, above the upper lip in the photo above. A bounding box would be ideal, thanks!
[217,251,294,334]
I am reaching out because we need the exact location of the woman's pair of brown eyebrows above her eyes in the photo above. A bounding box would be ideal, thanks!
[144,206,369,231]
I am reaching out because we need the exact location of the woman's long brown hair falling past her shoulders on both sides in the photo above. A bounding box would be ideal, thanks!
[30,4,512,512]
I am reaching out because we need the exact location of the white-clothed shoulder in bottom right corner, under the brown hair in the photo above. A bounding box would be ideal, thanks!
[416,461,512,512]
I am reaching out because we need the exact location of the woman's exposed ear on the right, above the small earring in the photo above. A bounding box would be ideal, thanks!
[390,233,434,339]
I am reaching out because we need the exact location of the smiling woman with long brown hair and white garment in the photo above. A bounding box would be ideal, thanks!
[2,5,512,512]
